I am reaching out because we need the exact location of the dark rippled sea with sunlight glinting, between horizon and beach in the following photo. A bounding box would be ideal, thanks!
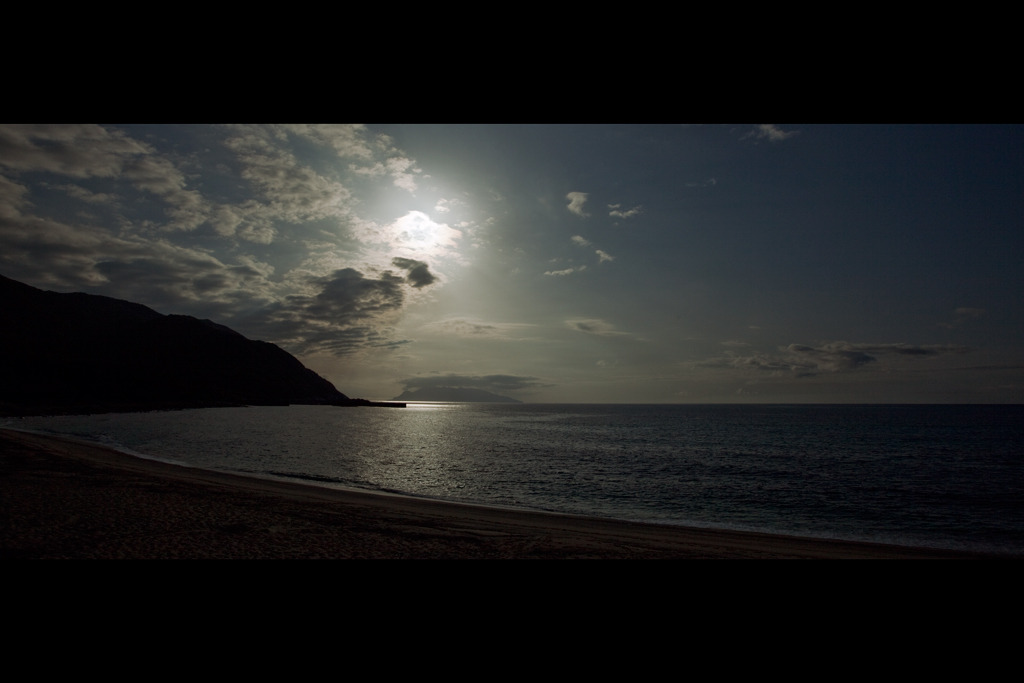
[0,403,1024,556]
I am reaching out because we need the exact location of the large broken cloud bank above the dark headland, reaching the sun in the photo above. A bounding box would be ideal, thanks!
[0,124,462,362]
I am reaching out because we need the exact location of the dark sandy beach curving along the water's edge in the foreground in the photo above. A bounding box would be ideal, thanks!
[0,430,997,559]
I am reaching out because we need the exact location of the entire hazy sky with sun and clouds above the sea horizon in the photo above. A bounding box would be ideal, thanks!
[0,123,1024,403]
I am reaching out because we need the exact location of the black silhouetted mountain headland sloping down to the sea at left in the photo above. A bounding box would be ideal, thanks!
[0,275,380,415]
